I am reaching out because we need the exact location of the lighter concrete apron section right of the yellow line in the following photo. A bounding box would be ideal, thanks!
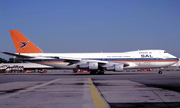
[94,80,180,108]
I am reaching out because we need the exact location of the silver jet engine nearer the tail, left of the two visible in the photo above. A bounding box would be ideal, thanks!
[79,62,98,70]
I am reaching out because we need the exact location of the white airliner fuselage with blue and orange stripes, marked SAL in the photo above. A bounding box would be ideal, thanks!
[17,50,179,69]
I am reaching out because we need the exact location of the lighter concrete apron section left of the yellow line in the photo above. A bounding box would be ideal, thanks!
[0,78,95,108]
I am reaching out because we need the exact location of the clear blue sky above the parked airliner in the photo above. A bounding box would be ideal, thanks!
[0,0,180,58]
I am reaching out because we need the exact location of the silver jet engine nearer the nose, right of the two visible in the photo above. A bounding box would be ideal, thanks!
[107,64,124,72]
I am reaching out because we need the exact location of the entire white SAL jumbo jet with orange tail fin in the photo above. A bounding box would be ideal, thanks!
[2,30,179,74]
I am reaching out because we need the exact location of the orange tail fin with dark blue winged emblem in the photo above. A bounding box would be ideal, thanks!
[9,30,43,53]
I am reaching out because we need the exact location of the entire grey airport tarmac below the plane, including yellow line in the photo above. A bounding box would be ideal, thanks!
[0,71,180,108]
